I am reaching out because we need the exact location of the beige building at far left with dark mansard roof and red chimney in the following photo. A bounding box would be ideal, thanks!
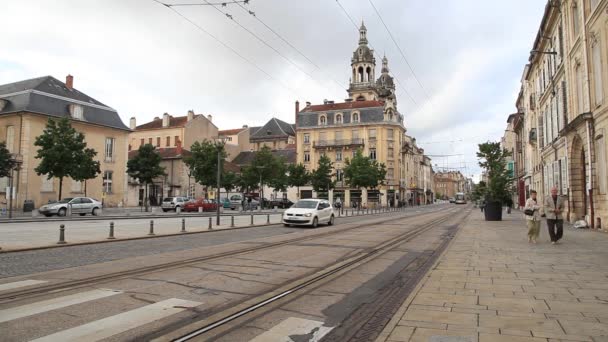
[0,75,130,209]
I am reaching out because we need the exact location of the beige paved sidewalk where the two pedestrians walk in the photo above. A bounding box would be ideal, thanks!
[378,210,608,342]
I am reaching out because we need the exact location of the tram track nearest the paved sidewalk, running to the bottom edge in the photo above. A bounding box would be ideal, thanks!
[145,206,470,342]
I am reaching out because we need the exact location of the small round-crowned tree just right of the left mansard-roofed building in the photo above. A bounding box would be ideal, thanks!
[127,144,165,211]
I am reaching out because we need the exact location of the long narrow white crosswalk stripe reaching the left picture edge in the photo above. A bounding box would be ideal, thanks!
[0,289,122,323]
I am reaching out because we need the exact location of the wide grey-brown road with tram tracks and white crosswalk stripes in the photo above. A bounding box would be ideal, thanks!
[0,205,469,341]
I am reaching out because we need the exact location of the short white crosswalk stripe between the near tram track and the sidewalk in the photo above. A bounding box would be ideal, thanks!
[250,317,334,342]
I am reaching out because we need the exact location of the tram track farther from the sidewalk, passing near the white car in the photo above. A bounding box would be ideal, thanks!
[0,206,456,304]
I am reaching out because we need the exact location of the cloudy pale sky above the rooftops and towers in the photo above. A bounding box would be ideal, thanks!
[0,0,546,179]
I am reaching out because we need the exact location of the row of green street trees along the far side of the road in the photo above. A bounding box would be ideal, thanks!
[0,118,386,210]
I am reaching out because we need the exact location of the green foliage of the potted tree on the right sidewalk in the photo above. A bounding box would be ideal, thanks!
[477,142,513,203]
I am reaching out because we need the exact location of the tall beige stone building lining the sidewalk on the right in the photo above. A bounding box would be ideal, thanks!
[510,0,608,227]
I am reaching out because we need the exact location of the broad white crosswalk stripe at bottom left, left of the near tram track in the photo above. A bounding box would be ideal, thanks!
[34,298,201,342]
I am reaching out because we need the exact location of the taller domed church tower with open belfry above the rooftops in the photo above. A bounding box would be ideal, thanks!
[348,22,379,101]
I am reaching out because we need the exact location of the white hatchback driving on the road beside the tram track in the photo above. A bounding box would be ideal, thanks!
[283,199,334,228]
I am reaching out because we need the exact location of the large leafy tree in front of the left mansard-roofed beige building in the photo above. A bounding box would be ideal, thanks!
[34,118,96,199]
